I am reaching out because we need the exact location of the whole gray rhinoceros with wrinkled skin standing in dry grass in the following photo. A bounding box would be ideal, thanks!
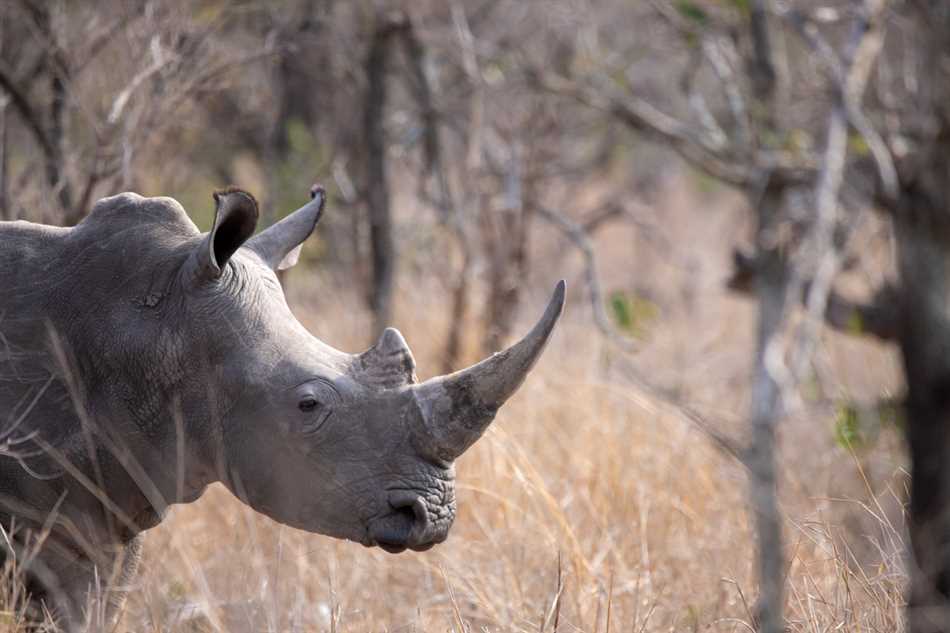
[0,188,564,630]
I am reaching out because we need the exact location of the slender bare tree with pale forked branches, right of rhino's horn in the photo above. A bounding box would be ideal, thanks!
[530,0,889,633]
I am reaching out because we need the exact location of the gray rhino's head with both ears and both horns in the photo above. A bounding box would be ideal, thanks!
[181,188,564,552]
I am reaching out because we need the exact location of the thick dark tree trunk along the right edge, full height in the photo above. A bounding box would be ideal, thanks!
[892,2,950,633]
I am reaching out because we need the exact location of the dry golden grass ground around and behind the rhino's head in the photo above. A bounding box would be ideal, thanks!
[5,170,908,632]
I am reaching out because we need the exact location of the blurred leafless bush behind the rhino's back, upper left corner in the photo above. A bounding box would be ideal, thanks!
[0,0,276,224]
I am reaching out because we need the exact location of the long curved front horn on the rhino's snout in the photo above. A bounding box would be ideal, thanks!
[411,280,564,462]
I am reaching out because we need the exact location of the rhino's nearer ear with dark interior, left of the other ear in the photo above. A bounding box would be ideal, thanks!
[195,188,259,279]
